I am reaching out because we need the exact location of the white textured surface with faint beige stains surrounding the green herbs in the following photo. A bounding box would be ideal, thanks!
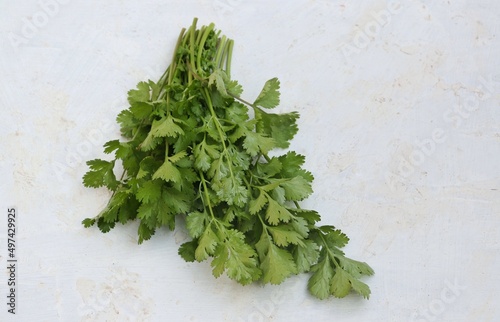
[0,0,500,322]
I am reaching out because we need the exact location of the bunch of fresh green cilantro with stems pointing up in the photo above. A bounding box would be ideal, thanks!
[83,19,373,299]
